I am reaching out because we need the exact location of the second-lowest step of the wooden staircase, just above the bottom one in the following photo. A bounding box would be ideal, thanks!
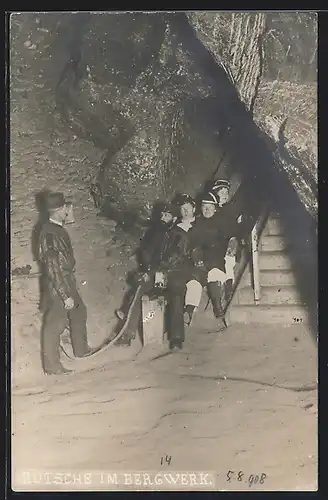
[236,285,302,305]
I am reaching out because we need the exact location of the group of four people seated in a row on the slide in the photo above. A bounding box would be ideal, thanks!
[116,179,247,349]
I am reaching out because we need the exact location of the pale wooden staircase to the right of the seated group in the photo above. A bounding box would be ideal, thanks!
[226,215,308,326]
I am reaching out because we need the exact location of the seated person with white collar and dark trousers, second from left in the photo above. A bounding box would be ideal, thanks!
[158,194,199,349]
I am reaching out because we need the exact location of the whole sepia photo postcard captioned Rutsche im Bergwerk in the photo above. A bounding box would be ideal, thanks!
[8,11,318,492]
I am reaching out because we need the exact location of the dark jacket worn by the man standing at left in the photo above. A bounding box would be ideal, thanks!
[39,221,76,301]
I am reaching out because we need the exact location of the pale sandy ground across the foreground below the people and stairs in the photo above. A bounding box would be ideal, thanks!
[12,312,317,490]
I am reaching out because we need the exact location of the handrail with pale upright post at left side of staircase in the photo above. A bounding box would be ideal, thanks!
[224,206,270,312]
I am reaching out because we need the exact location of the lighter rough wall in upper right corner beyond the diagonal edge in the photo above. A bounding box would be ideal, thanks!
[187,12,318,218]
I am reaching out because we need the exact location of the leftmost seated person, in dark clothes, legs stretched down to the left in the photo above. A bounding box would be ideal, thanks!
[115,204,176,346]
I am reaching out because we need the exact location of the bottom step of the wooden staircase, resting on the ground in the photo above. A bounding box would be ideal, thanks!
[226,304,308,326]
